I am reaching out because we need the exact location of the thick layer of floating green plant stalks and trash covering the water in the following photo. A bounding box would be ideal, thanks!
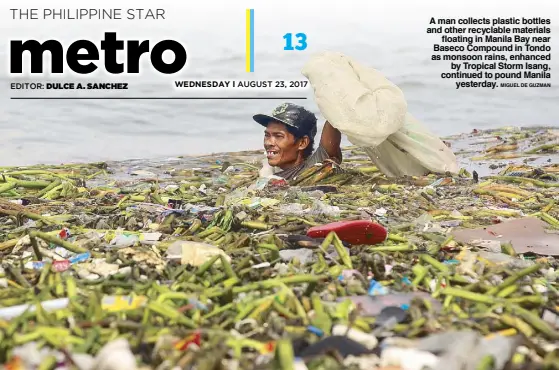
[0,128,559,370]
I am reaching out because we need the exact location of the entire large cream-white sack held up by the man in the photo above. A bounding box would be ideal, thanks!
[302,52,458,176]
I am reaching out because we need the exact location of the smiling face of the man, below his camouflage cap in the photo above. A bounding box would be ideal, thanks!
[264,121,308,169]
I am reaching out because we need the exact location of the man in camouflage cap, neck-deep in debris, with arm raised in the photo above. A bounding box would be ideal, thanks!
[253,103,342,180]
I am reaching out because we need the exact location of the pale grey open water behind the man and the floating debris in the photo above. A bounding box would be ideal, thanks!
[0,1,559,166]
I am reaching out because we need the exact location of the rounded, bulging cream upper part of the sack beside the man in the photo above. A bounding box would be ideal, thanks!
[302,52,407,146]
